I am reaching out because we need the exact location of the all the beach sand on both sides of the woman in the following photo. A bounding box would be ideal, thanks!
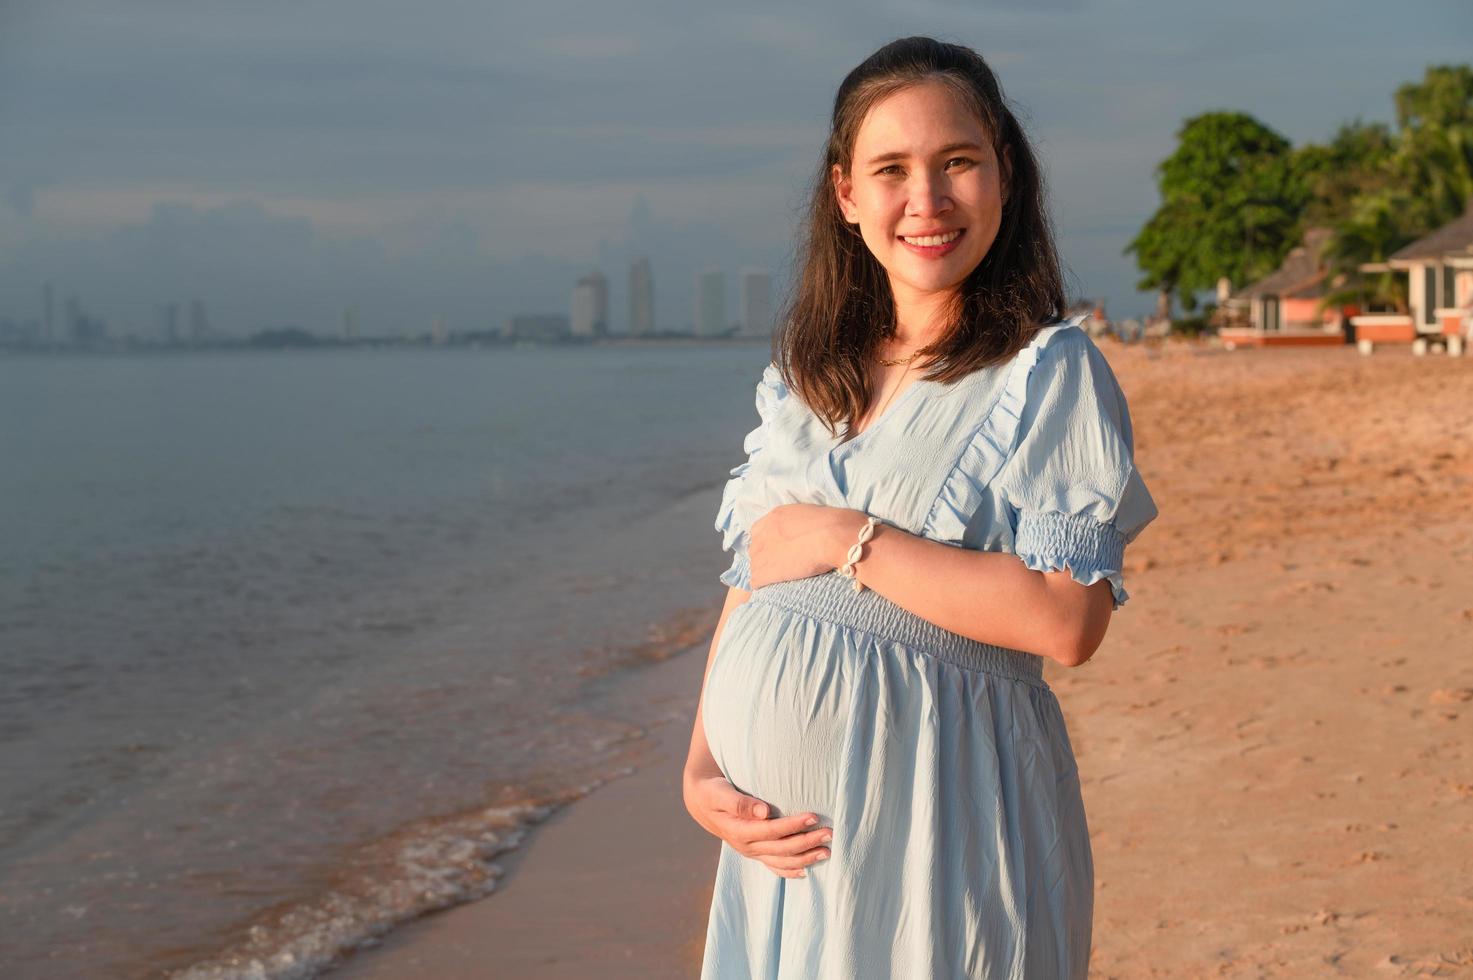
[333,340,1473,980]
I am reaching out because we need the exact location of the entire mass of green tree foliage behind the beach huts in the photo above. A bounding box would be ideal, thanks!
[1125,65,1473,309]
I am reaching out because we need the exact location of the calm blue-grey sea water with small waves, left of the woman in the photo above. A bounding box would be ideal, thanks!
[0,340,769,980]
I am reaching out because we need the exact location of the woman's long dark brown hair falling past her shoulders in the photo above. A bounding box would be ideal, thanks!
[773,37,1065,439]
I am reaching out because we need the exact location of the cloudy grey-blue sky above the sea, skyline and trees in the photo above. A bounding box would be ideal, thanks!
[0,0,1473,336]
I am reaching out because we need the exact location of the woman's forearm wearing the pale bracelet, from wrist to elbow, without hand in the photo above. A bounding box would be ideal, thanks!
[829,511,1114,666]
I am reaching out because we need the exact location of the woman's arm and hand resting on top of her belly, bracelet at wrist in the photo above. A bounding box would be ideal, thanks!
[750,504,1114,668]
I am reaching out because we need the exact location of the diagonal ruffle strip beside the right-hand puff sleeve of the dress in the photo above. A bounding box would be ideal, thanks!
[922,321,1089,547]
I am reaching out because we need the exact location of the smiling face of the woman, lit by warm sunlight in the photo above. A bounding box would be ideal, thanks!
[832,81,1006,309]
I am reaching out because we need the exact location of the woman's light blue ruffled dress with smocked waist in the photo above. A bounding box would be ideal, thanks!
[701,317,1156,980]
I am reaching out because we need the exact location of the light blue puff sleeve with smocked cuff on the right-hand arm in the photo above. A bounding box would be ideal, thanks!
[996,330,1156,609]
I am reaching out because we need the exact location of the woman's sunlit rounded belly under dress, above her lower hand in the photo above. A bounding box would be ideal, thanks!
[701,601,857,819]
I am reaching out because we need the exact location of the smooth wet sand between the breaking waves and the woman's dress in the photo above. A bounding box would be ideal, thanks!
[334,633,720,980]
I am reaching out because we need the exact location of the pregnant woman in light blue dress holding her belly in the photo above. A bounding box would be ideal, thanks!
[685,37,1156,980]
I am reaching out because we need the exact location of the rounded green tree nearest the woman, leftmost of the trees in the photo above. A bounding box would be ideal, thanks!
[1125,112,1307,311]
